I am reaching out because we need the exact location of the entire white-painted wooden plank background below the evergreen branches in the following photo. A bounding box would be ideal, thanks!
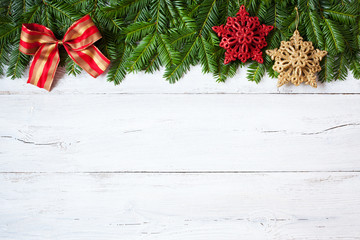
[0,67,360,240]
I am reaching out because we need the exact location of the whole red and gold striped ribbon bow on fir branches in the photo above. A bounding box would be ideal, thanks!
[19,15,110,91]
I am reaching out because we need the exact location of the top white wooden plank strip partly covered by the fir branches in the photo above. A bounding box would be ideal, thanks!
[0,67,360,95]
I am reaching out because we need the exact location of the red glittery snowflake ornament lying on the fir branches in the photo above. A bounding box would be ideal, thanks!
[212,5,274,64]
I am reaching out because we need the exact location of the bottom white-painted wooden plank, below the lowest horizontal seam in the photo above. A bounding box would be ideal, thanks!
[0,173,360,240]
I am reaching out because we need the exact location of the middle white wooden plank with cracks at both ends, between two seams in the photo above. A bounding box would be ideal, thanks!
[0,94,360,172]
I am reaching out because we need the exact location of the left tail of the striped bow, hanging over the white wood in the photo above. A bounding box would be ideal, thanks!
[28,43,60,91]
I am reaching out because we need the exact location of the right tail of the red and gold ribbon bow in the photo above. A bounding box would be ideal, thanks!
[64,44,110,78]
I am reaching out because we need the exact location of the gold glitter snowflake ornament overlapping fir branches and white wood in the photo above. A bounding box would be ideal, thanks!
[266,30,327,88]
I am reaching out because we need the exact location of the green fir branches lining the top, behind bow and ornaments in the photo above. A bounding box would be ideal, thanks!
[0,0,360,84]
